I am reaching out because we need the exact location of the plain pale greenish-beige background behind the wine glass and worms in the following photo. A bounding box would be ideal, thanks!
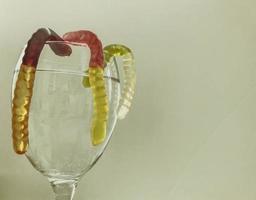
[0,0,256,200]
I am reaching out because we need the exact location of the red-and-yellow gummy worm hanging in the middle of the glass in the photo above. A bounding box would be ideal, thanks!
[63,30,109,145]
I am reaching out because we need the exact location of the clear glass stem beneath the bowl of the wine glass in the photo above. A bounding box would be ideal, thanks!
[50,179,77,200]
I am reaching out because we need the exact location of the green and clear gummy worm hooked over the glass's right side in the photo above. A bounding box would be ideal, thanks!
[104,44,136,119]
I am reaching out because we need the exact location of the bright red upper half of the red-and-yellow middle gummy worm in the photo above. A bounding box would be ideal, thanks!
[63,30,104,68]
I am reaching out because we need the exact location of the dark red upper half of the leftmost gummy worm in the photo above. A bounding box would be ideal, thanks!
[22,28,72,68]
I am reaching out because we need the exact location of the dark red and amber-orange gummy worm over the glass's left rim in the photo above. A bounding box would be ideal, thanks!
[12,28,71,154]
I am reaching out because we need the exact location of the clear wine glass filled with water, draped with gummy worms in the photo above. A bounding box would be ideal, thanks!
[12,41,124,200]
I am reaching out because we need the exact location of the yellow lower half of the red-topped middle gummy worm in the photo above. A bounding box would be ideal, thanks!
[88,67,109,145]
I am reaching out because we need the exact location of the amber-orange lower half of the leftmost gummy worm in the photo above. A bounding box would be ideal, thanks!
[12,65,36,154]
